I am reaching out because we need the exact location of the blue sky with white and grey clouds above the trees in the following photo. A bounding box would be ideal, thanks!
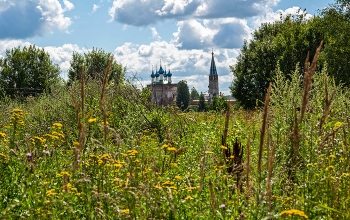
[0,0,333,94]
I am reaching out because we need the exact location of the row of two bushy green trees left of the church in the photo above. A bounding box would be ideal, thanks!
[0,45,125,98]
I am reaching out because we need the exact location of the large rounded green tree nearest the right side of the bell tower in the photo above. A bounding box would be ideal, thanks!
[230,13,322,108]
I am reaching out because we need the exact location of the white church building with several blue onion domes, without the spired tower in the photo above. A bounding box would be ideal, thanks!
[147,63,177,105]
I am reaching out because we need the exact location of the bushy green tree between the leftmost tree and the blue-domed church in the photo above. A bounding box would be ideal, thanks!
[68,48,125,85]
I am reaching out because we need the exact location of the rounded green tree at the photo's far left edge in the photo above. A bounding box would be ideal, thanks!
[0,45,60,97]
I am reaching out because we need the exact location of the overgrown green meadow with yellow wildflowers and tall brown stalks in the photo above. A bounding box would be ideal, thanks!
[0,67,350,219]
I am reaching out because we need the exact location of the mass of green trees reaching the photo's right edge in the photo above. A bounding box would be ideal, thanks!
[230,0,350,109]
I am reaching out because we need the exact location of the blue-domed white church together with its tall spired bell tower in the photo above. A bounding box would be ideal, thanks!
[147,52,219,106]
